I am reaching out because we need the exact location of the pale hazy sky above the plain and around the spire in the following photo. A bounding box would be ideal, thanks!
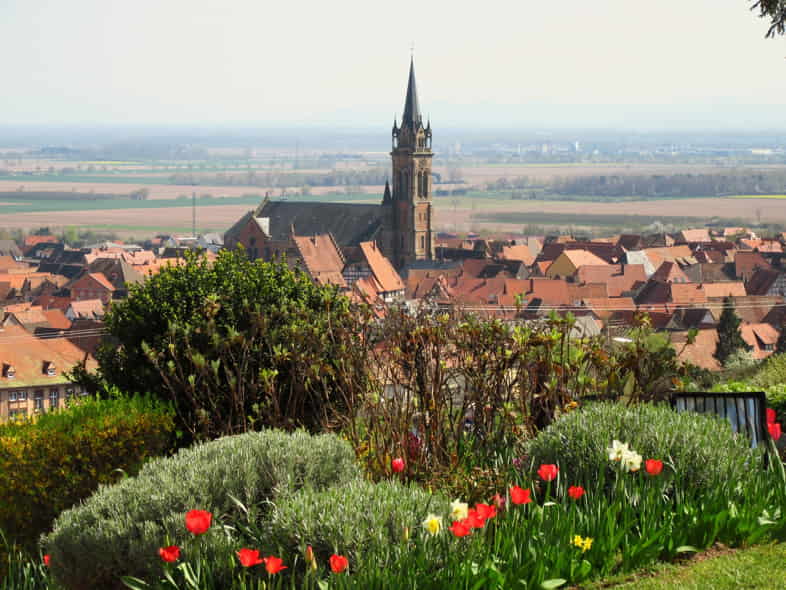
[0,0,786,129]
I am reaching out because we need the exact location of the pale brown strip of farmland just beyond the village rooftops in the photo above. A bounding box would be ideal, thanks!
[0,195,786,237]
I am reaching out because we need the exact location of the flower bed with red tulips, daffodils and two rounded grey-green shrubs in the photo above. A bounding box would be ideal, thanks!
[33,406,786,590]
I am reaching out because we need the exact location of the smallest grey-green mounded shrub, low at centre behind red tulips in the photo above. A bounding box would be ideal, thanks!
[259,479,449,567]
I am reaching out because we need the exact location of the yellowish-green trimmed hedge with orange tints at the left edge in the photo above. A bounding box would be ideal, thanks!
[0,397,174,549]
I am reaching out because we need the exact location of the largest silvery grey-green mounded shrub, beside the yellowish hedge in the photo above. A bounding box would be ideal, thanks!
[44,431,359,590]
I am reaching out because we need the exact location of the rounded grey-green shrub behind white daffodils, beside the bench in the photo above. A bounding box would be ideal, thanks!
[527,403,754,493]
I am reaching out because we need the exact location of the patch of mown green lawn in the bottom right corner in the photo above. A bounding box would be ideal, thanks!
[575,543,786,590]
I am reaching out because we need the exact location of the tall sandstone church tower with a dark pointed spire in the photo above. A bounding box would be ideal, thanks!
[386,60,434,268]
